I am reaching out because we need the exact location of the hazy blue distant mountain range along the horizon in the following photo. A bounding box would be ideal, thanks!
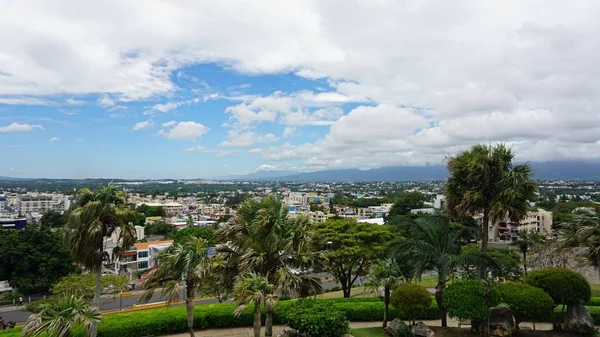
[230,161,600,181]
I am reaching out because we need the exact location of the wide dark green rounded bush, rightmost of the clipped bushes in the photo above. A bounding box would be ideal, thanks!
[525,268,592,306]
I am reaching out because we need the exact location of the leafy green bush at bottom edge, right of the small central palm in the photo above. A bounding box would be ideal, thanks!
[286,300,350,337]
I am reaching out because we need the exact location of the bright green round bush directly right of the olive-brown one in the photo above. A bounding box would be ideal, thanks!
[443,280,500,322]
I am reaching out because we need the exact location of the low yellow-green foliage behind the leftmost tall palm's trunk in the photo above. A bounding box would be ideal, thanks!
[52,274,129,300]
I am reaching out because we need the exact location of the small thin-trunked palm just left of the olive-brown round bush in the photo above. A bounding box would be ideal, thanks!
[369,259,403,328]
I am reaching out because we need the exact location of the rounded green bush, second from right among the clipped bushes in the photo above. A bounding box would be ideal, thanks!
[497,282,554,325]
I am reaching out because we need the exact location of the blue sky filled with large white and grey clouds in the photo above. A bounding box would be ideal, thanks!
[0,0,600,178]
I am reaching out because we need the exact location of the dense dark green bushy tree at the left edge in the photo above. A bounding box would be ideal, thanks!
[0,225,74,295]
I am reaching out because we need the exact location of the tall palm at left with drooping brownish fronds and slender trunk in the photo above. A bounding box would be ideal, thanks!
[67,183,136,337]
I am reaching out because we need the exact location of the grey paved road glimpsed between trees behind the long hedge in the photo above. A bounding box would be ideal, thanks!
[0,282,338,323]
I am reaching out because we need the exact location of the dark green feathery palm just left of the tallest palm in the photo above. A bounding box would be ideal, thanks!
[396,217,487,327]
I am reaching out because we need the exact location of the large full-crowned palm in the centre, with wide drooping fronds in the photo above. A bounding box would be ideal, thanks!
[217,196,323,337]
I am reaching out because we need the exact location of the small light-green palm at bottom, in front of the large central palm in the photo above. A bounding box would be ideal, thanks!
[233,272,279,337]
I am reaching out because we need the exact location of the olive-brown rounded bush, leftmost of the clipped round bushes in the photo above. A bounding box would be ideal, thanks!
[390,284,431,322]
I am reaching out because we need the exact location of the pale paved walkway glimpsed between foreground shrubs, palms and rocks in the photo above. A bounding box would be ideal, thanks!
[164,318,552,337]
